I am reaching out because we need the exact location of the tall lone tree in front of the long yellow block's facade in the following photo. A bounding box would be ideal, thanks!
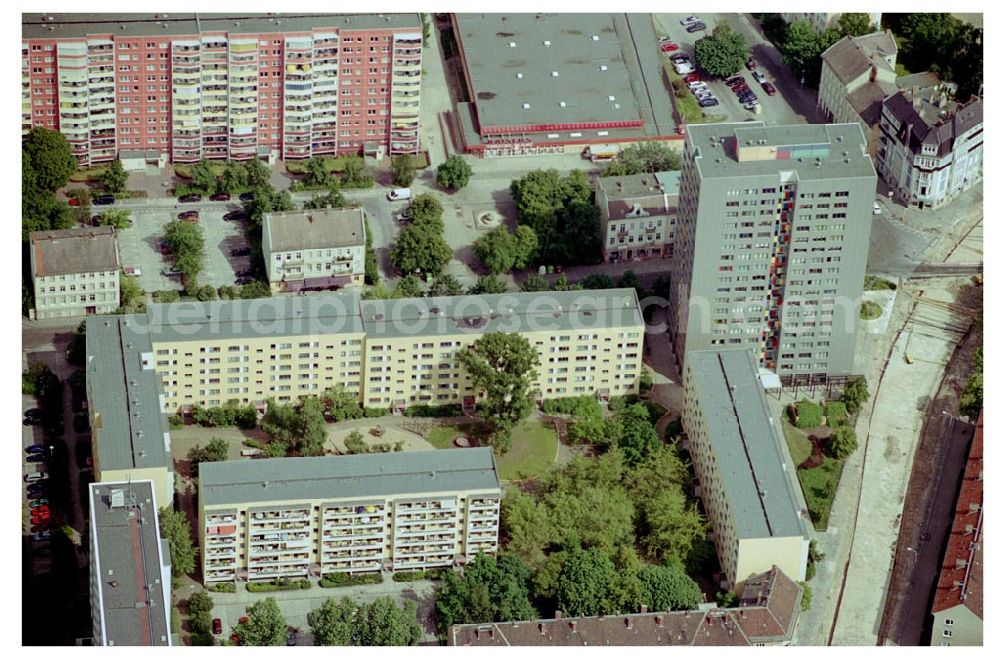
[458,332,538,446]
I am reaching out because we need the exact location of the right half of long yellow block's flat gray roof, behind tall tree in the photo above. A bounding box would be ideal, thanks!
[361,289,643,339]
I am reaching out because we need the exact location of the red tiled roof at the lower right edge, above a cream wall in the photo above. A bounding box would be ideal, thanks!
[931,413,983,618]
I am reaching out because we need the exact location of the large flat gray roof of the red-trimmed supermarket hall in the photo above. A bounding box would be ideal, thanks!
[455,13,675,139]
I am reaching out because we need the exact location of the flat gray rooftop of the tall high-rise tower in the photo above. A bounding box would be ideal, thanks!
[687,121,875,181]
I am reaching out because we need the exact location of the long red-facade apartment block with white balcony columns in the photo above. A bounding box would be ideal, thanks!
[21,14,423,166]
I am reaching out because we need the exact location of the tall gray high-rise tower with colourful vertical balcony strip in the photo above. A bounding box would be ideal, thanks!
[668,123,876,382]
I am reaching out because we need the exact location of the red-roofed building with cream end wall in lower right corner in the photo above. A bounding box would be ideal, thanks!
[931,414,986,645]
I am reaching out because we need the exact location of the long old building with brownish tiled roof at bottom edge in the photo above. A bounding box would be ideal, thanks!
[448,567,802,647]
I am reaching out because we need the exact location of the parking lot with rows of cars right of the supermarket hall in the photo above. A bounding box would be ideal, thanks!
[653,13,817,125]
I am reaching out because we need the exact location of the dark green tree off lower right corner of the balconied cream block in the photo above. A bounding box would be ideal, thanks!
[435,554,537,632]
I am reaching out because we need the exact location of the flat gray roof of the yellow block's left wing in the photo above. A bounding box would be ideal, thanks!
[86,316,173,470]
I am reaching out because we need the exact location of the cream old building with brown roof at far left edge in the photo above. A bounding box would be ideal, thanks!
[29,227,121,319]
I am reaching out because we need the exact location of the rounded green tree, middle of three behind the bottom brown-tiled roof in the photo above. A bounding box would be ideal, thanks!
[556,548,619,616]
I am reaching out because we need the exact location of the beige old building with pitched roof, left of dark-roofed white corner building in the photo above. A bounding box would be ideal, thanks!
[819,30,898,156]
